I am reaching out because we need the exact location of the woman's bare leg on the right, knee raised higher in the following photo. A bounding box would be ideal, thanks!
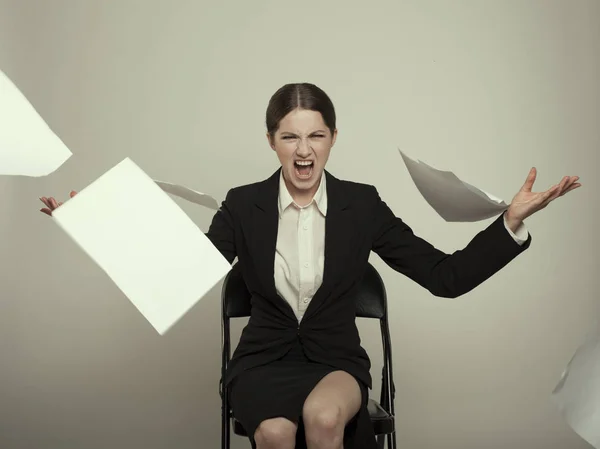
[302,371,362,449]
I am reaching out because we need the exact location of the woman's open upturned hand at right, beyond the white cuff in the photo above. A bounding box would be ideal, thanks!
[506,168,581,228]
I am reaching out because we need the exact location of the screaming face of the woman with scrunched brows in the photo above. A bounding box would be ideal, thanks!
[267,109,337,195]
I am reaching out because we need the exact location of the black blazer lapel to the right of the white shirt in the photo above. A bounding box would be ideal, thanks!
[304,171,356,318]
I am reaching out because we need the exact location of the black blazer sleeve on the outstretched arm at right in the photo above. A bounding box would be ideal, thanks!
[372,188,531,298]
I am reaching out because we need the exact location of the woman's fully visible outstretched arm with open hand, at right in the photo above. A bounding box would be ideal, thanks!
[372,169,580,298]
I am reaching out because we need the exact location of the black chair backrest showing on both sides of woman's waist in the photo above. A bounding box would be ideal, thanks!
[222,263,387,320]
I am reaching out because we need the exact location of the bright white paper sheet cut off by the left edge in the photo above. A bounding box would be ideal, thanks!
[0,71,72,176]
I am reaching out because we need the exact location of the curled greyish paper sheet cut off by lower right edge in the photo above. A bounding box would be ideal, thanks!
[552,333,600,449]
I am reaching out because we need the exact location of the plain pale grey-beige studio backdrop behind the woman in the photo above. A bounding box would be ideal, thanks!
[0,0,600,449]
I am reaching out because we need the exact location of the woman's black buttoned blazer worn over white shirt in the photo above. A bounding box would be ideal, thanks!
[207,169,531,387]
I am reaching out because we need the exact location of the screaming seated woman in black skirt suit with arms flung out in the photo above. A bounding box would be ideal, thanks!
[42,83,580,449]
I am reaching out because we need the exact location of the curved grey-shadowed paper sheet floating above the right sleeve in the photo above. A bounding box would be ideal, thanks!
[398,150,508,222]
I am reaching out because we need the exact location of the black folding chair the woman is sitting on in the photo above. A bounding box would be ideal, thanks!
[220,264,396,449]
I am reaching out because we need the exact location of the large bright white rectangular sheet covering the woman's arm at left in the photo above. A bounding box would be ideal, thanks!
[53,158,231,334]
